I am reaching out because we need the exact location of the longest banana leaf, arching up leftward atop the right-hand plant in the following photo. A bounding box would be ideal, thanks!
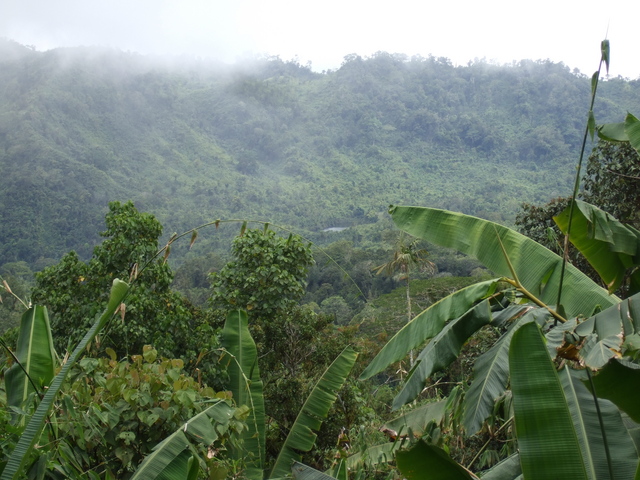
[389,206,618,317]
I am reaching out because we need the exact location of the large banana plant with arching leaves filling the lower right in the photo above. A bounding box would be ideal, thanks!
[362,204,640,479]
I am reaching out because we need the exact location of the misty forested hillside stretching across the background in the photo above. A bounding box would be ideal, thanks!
[0,40,640,269]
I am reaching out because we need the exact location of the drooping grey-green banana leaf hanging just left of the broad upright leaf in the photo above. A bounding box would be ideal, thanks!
[463,307,552,435]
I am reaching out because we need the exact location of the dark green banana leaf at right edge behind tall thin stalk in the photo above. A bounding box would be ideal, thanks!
[554,200,640,293]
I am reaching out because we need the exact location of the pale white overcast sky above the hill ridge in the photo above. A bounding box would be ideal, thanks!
[0,0,640,79]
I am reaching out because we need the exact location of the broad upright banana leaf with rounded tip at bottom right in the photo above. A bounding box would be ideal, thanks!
[509,322,588,480]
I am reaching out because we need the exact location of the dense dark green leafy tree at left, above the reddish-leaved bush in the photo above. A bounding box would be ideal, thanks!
[32,202,210,361]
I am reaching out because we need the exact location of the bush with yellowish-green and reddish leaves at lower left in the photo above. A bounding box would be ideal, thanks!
[56,346,236,478]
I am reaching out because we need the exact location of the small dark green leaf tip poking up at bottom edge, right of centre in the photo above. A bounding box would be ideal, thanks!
[396,440,475,480]
